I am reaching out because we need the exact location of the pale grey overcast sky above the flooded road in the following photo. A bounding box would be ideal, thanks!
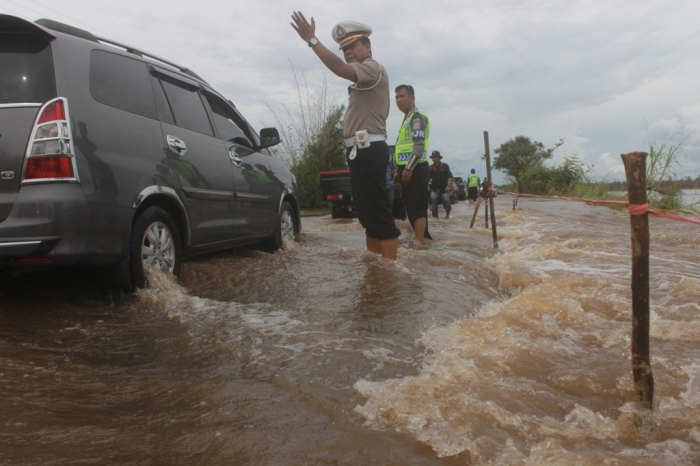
[0,0,700,183]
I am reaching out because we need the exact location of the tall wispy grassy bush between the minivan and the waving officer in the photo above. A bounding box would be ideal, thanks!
[268,65,347,209]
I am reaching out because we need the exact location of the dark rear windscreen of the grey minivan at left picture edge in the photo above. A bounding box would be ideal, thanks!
[0,32,56,105]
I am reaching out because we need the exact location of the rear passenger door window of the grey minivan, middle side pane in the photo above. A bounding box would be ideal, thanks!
[159,75,214,136]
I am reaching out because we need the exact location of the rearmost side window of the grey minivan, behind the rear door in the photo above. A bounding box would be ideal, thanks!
[90,50,158,120]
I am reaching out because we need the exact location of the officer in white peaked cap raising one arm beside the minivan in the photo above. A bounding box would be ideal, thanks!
[291,11,401,260]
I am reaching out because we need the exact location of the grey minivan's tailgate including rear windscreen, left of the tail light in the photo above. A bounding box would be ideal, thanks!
[0,23,56,222]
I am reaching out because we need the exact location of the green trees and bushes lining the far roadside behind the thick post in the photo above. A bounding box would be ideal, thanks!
[493,136,700,213]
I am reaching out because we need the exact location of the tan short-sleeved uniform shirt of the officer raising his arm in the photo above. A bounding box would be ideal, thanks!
[343,58,391,139]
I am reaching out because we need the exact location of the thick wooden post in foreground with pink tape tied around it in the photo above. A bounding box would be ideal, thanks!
[621,152,654,410]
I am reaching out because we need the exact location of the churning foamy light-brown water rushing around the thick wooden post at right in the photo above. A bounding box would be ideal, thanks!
[355,200,700,465]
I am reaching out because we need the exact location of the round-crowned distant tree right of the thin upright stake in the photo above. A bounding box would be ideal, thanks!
[493,136,564,192]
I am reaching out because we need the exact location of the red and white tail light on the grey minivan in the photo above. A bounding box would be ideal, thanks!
[22,97,80,184]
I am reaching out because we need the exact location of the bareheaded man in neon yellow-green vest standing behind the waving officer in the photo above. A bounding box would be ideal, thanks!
[394,84,433,244]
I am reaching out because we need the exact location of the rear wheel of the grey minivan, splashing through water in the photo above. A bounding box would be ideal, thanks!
[129,207,182,288]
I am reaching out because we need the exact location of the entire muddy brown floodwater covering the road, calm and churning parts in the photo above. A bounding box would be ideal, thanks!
[0,196,700,465]
